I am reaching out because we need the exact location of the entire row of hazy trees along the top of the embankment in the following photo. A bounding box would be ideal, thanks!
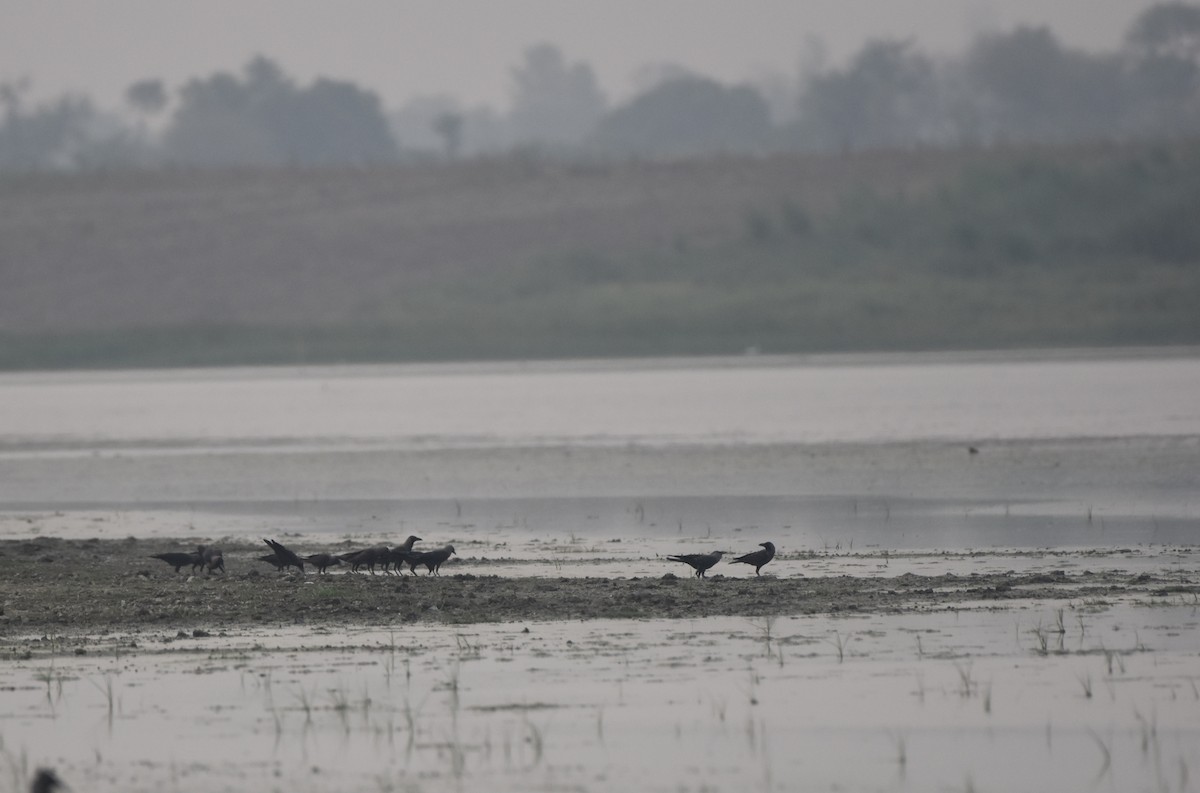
[0,2,1200,172]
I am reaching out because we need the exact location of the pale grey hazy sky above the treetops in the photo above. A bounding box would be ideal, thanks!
[0,0,1153,108]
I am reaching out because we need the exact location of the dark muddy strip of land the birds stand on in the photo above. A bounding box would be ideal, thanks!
[0,537,1200,636]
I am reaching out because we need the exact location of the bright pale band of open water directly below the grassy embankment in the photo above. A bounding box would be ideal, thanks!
[7,353,1200,451]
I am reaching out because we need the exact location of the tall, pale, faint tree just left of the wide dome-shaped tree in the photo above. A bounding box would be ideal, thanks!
[511,44,607,146]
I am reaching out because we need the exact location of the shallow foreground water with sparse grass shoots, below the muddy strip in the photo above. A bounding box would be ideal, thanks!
[0,600,1200,793]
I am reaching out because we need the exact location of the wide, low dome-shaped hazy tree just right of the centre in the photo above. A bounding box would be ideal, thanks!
[594,77,770,156]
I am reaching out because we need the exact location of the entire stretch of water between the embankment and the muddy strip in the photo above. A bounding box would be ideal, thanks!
[0,350,1200,549]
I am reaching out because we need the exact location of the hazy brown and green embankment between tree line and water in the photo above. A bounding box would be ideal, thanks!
[0,139,1200,368]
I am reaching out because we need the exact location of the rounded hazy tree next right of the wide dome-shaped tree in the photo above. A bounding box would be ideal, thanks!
[797,41,938,150]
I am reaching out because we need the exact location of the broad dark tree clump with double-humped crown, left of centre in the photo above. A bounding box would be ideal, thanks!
[163,58,396,166]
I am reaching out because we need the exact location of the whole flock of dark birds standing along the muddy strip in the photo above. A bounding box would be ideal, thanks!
[150,535,775,578]
